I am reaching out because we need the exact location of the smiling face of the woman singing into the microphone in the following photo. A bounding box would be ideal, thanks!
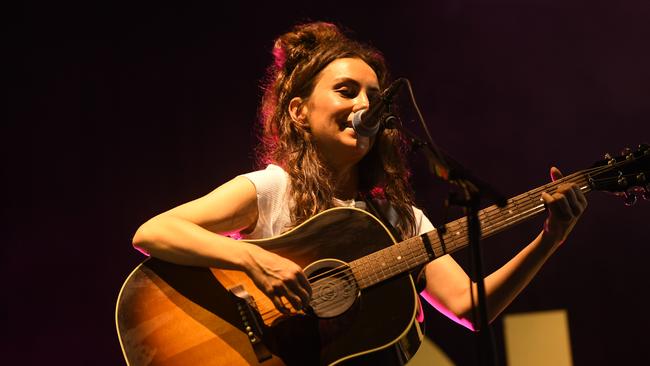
[300,58,380,168]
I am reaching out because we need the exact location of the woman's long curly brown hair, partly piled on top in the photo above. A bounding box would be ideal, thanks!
[257,22,415,238]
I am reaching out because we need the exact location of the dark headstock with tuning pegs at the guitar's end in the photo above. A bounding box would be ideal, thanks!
[587,144,650,206]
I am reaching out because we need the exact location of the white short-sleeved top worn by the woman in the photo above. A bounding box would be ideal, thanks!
[242,164,434,239]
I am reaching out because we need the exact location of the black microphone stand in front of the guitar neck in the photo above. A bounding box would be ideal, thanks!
[382,109,507,366]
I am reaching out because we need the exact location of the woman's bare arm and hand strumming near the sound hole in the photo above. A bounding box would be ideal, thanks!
[133,177,311,311]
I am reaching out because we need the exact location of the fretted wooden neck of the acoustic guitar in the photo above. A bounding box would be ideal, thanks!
[349,171,591,288]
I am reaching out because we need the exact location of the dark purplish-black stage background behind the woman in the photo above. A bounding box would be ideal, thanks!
[6,0,650,365]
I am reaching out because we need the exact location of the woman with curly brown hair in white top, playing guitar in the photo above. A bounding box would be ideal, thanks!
[133,23,587,364]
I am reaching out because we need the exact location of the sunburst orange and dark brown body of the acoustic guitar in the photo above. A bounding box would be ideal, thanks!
[116,208,422,365]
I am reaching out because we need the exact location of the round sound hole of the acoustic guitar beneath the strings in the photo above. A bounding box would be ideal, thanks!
[304,259,359,318]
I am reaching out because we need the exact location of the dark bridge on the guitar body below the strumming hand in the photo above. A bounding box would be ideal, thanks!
[229,285,273,362]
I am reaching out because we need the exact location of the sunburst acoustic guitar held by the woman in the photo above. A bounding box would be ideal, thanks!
[115,145,650,366]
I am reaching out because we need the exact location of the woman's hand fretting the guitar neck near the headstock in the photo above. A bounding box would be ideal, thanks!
[542,167,587,245]
